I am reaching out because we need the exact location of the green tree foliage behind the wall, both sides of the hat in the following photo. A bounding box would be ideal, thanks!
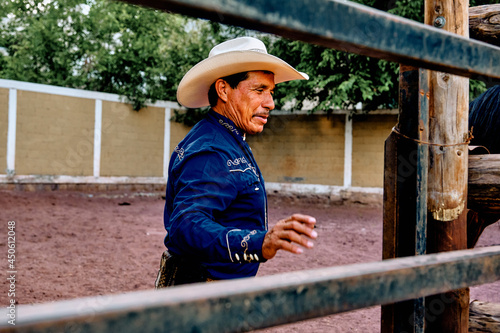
[0,0,497,123]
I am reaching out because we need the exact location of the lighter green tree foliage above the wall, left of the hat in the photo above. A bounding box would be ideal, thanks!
[0,0,217,109]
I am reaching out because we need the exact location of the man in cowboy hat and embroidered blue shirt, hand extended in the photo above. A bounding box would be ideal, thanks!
[156,37,317,288]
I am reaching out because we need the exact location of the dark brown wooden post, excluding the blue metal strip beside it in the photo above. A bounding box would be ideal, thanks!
[381,66,418,333]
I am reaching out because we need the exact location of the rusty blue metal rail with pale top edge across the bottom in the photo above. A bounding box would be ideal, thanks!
[6,246,500,333]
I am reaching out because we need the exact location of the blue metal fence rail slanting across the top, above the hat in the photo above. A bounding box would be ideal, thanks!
[122,0,500,80]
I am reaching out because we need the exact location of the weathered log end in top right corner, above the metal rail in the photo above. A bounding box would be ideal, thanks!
[469,4,500,46]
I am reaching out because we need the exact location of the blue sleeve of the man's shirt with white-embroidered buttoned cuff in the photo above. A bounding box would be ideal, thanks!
[165,151,266,262]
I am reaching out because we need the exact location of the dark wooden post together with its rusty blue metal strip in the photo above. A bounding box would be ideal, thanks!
[381,65,428,333]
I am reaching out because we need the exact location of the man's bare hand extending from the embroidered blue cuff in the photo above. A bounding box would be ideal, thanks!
[262,214,318,259]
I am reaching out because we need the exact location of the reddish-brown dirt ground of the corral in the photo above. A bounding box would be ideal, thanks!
[0,191,500,333]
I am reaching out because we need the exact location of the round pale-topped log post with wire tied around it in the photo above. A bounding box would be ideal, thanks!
[425,0,469,333]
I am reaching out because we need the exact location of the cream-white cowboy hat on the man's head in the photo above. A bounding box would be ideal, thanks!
[177,37,309,108]
